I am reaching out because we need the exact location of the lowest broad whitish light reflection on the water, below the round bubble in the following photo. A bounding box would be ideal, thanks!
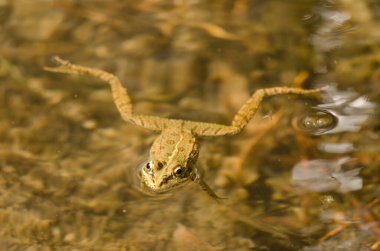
[292,157,363,193]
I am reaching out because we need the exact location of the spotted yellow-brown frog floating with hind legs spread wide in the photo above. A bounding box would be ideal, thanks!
[45,57,320,198]
